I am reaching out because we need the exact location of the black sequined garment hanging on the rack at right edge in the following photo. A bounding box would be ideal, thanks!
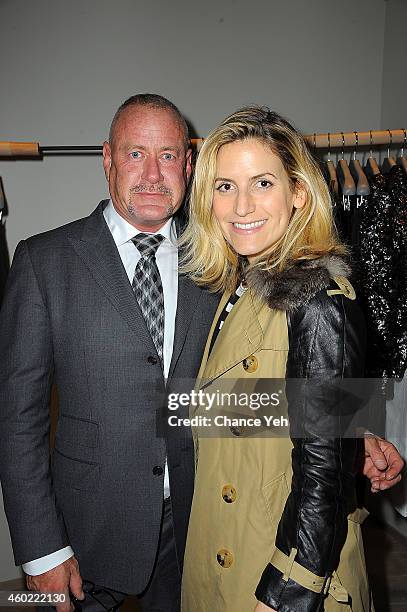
[352,166,407,378]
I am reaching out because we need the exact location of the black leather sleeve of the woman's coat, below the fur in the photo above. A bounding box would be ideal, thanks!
[256,290,365,612]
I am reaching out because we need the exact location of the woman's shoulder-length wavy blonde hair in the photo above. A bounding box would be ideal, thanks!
[180,106,346,291]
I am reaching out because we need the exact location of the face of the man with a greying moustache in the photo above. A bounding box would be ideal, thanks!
[103,106,191,232]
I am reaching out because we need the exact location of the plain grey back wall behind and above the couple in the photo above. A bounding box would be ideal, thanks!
[0,0,407,580]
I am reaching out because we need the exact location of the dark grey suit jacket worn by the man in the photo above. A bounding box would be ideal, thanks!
[0,202,218,593]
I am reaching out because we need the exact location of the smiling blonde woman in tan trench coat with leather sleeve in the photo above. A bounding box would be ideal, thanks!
[183,107,373,612]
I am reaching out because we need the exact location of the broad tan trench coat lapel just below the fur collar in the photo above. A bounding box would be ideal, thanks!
[199,289,263,384]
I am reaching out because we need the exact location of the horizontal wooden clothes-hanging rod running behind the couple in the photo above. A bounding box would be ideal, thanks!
[0,129,407,159]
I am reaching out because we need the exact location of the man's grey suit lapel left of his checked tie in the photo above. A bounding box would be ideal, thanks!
[70,200,155,342]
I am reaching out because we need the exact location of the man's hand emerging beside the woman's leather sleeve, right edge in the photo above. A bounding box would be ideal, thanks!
[363,435,404,493]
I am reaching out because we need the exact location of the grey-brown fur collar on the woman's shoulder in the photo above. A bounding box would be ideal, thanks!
[246,255,351,310]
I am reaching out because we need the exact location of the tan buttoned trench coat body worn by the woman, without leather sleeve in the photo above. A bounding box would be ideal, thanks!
[182,289,373,612]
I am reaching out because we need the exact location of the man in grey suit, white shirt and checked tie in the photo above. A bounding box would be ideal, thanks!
[0,94,400,612]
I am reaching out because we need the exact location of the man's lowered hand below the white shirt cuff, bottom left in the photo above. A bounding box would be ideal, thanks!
[26,557,85,612]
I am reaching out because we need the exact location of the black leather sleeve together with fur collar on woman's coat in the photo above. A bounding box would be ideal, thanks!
[246,257,366,612]
